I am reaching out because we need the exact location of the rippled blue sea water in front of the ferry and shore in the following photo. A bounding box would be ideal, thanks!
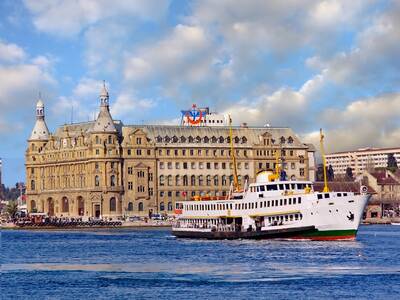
[1,225,400,299]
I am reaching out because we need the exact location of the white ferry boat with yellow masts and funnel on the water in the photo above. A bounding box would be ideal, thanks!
[172,127,370,240]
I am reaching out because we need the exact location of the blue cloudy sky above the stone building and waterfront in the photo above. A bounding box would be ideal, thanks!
[0,0,400,185]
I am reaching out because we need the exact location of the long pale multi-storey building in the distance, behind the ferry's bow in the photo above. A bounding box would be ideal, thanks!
[325,147,400,176]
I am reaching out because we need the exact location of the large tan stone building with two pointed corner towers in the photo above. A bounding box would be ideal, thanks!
[26,86,315,217]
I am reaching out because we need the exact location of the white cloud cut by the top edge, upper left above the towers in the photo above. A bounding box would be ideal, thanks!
[25,0,169,36]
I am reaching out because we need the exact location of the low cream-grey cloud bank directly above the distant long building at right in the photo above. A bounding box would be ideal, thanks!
[304,93,400,152]
